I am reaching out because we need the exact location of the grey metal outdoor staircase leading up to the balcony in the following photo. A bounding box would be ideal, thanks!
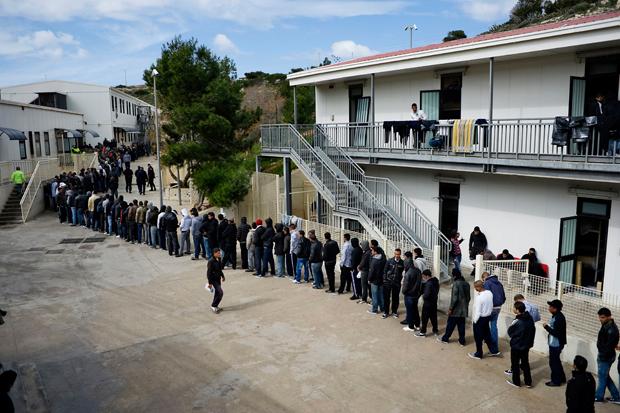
[261,124,450,275]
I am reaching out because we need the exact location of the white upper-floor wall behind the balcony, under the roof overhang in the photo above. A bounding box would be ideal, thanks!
[316,53,585,123]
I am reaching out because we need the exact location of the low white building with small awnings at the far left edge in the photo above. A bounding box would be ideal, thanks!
[0,100,84,162]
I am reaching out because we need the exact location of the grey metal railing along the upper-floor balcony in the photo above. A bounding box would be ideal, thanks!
[320,119,620,164]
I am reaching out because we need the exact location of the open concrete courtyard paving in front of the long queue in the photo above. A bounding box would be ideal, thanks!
[0,214,615,413]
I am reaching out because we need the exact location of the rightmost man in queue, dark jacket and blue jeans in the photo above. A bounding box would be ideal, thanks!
[595,307,620,404]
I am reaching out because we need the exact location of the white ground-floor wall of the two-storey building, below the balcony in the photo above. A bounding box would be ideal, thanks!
[365,166,620,294]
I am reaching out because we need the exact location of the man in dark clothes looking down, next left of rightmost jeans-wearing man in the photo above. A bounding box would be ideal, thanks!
[543,300,566,387]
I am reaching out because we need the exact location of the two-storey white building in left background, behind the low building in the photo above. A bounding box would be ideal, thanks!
[0,80,152,147]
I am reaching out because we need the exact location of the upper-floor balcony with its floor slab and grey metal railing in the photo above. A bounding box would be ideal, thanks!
[318,119,620,182]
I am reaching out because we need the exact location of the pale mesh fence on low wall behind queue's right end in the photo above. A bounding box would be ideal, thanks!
[483,261,620,340]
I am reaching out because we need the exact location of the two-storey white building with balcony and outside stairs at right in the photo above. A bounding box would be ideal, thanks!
[262,12,620,294]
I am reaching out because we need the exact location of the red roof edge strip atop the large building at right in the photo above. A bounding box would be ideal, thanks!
[312,11,620,70]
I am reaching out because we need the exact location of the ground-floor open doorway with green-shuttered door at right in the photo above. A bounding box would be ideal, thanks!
[557,198,611,289]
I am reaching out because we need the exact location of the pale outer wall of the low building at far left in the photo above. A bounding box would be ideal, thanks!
[0,102,83,161]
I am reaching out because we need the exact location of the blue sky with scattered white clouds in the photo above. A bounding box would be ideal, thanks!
[0,0,516,87]
